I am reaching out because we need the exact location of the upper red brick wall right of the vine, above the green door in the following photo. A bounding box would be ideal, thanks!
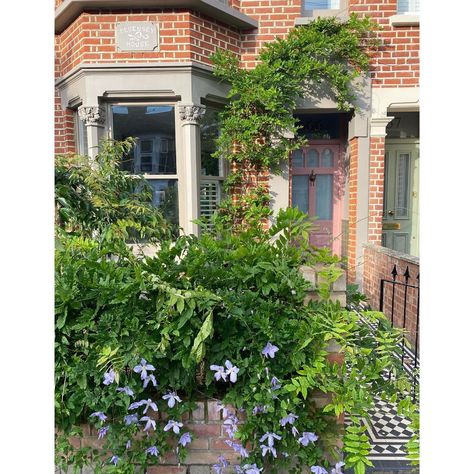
[349,0,420,87]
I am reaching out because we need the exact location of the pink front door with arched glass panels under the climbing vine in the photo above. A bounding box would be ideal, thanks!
[291,140,343,255]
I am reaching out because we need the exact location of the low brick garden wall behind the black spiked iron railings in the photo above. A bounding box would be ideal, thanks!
[363,245,420,346]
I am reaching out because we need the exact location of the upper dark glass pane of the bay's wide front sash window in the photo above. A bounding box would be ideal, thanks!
[112,105,176,174]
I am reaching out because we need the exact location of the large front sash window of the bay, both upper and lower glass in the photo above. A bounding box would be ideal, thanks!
[112,104,179,224]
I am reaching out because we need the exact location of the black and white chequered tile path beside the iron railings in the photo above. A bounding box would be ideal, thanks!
[346,308,419,474]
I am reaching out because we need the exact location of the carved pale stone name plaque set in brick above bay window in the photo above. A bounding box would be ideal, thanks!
[115,21,158,51]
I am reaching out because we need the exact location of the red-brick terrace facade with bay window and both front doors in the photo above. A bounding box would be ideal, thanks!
[55,0,419,296]
